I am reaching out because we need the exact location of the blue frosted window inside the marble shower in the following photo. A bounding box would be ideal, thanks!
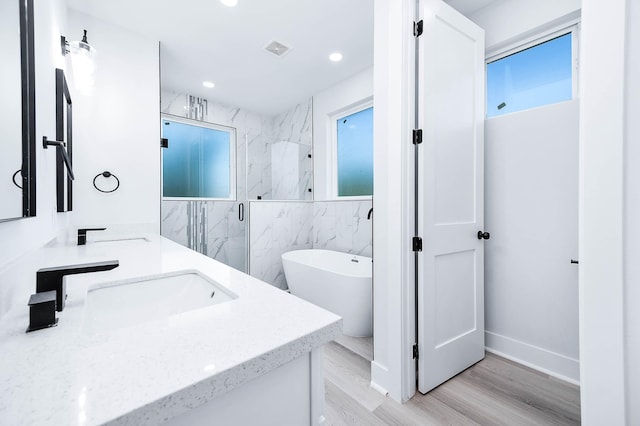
[162,117,236,199]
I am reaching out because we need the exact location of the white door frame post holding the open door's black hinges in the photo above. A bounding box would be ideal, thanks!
[371,0,418,402]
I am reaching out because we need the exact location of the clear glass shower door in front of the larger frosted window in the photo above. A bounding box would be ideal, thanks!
[161,110,248,272]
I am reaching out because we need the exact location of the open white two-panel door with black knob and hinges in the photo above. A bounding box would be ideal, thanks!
[417,0,485,393]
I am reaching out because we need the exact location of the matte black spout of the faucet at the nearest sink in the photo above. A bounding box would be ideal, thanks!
[36,260,120,312]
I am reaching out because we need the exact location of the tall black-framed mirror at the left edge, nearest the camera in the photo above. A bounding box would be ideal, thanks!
[0,0,36,221]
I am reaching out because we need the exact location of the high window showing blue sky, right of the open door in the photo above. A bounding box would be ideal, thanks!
[487,30,575,117]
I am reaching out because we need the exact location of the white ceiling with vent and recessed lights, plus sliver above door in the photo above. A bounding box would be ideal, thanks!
[67,0,492,114]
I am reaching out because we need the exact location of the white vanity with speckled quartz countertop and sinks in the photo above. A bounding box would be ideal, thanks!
[0,235,341,425]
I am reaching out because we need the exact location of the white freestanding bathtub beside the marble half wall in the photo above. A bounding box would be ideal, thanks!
[282,249,373,337]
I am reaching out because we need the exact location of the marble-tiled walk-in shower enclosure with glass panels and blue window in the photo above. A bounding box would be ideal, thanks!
[161,90,313,273]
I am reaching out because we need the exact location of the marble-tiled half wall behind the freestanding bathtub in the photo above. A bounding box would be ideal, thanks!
[249,200,372,289]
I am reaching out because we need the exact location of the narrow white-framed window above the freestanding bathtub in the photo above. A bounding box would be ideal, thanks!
[334,102,373,197]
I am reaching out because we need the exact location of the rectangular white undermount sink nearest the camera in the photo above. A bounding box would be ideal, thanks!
[83,270,238,334]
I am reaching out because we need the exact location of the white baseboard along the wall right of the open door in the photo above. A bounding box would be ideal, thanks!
[484,331,580,386]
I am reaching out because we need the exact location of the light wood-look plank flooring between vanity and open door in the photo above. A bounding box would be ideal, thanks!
[324,339,580,426]
